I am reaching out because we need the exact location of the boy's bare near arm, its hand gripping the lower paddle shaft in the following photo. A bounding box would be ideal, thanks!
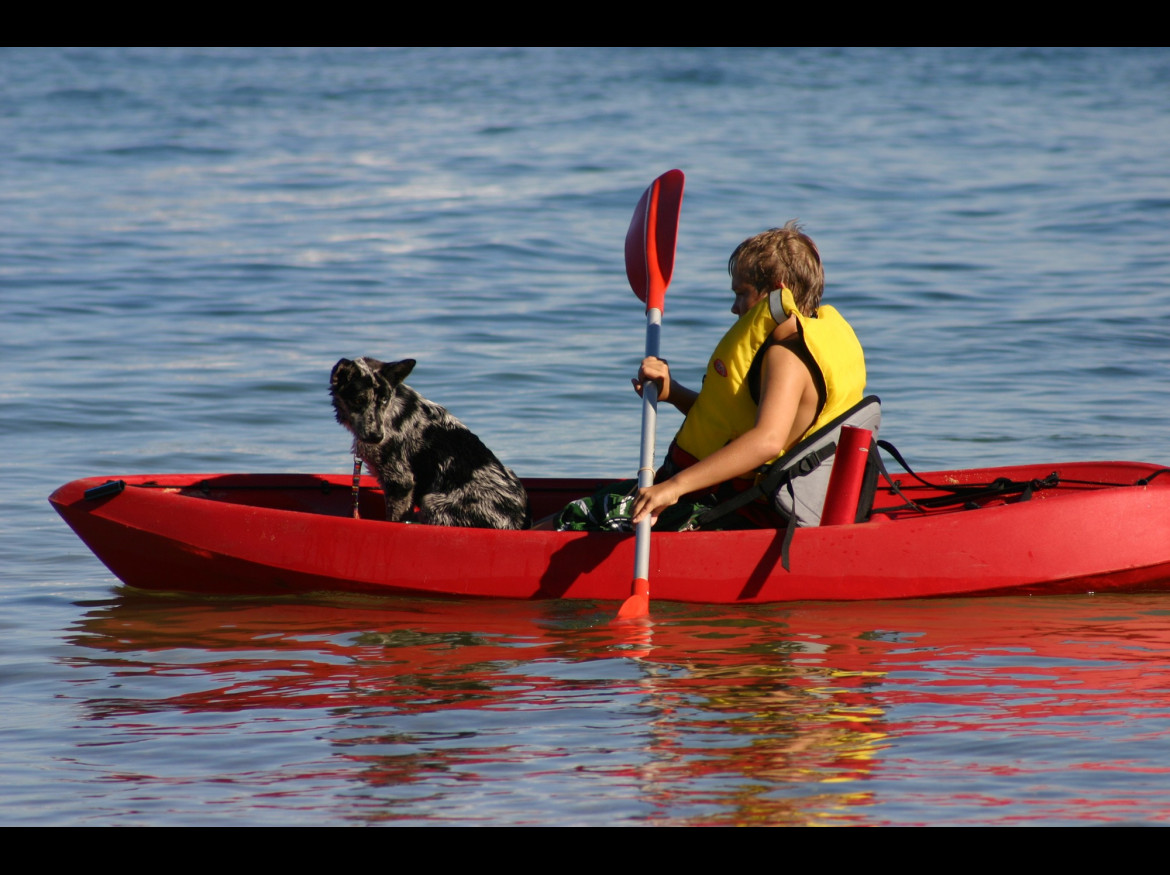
[633,346,817,523]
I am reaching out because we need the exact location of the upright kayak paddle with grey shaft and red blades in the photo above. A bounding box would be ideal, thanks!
[618,170,686,620]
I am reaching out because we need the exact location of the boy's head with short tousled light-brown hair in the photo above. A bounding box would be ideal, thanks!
[728,219,825,316]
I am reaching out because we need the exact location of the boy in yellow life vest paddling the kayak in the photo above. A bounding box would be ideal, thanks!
[558,221,866,529]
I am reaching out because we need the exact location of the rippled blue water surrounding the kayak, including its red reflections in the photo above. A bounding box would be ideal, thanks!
[0,49,1170,825]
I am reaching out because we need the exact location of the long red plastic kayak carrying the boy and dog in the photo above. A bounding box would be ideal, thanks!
[49,462,1170,604]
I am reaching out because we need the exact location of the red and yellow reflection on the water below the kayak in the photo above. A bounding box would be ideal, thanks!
[66,595,1170,824]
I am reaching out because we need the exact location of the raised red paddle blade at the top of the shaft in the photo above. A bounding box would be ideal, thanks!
[626,170,686,311]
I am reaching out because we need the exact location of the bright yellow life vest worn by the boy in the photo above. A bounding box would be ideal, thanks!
[674,288,866,461]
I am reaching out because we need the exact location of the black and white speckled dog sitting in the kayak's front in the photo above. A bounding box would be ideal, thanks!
[329,358,532,529]
